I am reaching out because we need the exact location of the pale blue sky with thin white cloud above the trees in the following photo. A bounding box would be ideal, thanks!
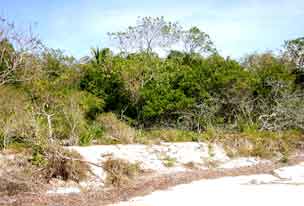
[0,0,304,58]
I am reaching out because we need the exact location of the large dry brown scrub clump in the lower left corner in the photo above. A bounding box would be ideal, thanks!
[0,145,90,196]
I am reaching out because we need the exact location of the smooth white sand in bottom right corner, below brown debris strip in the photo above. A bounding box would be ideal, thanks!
[112,163,304,206]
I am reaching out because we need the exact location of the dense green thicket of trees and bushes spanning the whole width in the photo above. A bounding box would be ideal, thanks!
[0,17,304,147]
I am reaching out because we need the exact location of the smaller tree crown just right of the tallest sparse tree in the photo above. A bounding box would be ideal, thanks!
[181,27,216,53]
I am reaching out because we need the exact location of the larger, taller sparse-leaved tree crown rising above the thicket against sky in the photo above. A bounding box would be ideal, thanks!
[108,17,180,53]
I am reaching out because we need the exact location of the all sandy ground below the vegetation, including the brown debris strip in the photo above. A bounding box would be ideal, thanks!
[0,142,304,206]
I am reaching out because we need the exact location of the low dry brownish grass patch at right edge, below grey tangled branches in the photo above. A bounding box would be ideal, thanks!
[218,131,304,161]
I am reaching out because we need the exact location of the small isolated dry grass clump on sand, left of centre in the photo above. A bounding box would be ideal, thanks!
[103,157,142,187]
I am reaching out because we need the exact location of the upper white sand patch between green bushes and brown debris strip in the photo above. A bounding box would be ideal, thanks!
[47,142,274,194]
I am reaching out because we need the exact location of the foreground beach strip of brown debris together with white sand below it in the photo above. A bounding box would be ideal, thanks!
[0,150,304,206]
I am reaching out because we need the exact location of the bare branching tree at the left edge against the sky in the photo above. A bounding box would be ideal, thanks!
[0,16,42,85]
